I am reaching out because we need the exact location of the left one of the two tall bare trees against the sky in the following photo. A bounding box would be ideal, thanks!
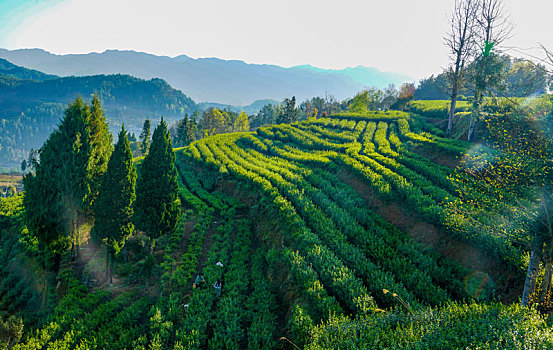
[444,0,480,135]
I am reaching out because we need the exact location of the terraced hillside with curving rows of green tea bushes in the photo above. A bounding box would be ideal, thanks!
[0,112,553,349]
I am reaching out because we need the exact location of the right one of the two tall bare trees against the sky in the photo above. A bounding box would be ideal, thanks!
[468,0,513,141]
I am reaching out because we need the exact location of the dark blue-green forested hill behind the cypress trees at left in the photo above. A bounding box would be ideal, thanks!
[0,62,196,169]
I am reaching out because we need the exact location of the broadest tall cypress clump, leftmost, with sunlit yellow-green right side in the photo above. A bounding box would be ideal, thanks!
[25,97,112,262]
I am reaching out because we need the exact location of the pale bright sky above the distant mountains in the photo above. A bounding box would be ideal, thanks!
[0,0,553,80]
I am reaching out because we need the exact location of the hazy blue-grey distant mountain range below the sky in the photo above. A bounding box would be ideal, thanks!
[0,49,412,106]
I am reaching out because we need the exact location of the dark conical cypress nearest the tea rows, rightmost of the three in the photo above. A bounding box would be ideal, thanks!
[134,118,180,247]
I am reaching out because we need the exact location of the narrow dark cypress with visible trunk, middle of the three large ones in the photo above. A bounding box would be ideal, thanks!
[93,125,136,283]
